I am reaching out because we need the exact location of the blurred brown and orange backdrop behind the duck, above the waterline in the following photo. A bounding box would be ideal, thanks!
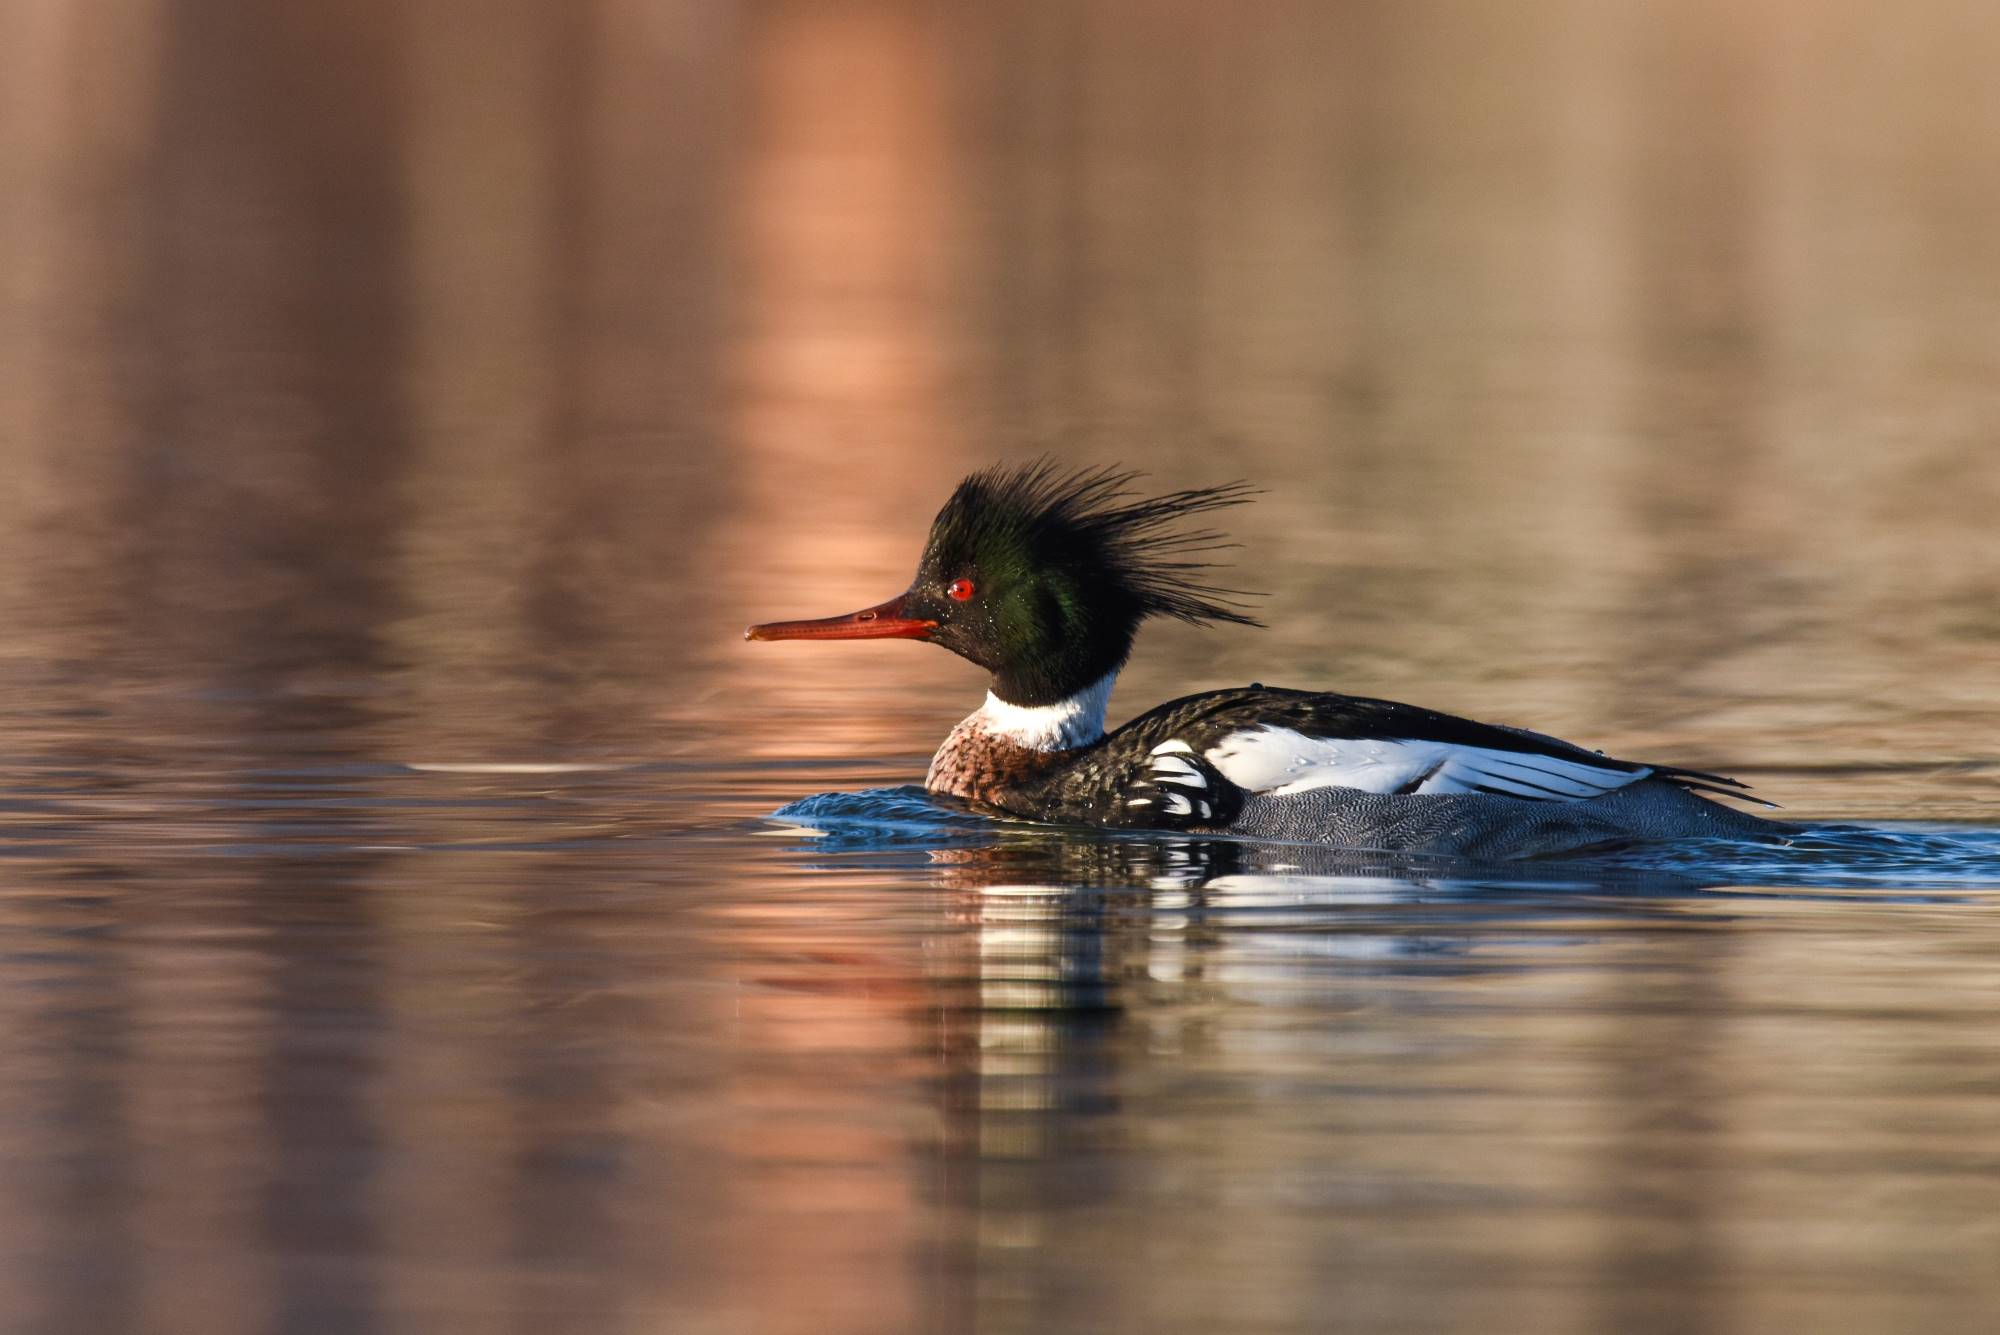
[0,0,2000,815]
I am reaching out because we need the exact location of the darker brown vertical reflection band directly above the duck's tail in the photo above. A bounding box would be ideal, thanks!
[1616,4,1790,725]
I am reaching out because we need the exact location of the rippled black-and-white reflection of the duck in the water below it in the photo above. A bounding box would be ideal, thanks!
[908,835,1736,1329]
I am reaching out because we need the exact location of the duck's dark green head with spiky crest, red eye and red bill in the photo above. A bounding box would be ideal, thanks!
[744,460,1258,705]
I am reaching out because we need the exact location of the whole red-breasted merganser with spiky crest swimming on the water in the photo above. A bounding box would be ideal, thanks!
[744,460,1790,857]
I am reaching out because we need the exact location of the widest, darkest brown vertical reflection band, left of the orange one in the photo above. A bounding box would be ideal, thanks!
[136,2,408,1331]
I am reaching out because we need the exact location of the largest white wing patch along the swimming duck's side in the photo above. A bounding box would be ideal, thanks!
[1206,725,1652,801]
